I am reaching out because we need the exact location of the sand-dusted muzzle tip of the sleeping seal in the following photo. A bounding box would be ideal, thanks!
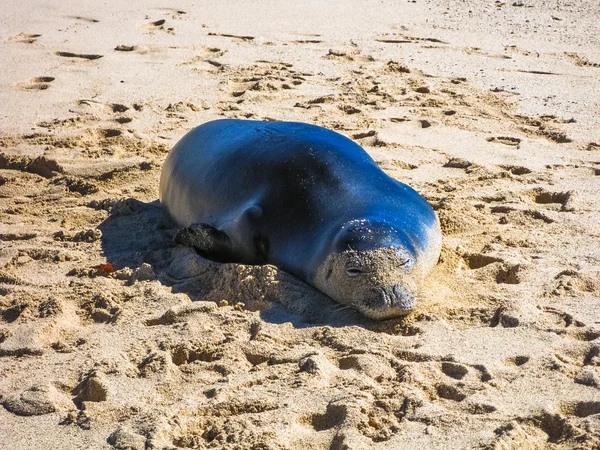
[360,284,417,320]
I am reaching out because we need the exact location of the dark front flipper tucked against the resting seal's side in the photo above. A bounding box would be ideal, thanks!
[175,223,237,263]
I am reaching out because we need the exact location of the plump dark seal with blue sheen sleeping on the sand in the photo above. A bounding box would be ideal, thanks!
[160,119,442,319]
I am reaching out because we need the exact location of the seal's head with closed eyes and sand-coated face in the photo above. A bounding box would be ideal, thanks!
[314,219,439,319]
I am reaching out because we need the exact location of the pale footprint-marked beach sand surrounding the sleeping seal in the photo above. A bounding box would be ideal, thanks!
[0,0,600,450]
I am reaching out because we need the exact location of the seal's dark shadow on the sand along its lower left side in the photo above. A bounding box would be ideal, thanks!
[99,198,371,328]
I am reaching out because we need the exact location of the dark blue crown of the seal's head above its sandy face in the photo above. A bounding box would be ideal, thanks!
[335,219,415,254]
